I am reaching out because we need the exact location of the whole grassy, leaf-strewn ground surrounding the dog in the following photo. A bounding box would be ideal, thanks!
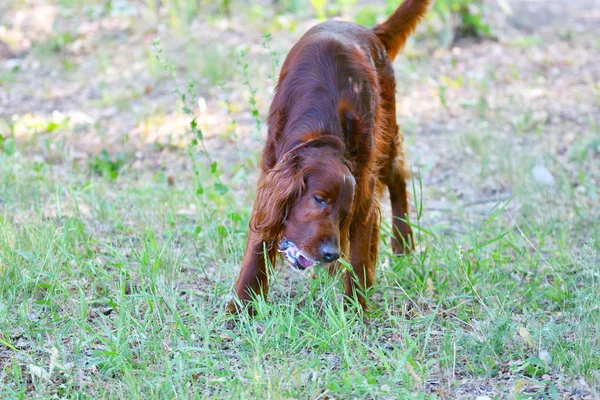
[0,0,600,398]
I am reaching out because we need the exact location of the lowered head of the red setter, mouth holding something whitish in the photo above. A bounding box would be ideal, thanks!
[250,136,356,269]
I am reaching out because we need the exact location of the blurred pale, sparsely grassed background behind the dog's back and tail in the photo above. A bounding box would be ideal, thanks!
[0,0,600,212]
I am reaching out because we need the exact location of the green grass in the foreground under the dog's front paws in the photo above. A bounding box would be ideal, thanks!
[0,132,600,398]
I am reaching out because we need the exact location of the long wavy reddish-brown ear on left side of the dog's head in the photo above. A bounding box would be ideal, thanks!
[250,154,304,244]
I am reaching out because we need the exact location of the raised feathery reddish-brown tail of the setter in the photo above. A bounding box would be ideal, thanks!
[373,0,430,61]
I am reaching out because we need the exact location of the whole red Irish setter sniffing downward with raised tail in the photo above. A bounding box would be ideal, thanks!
[228,0,430,312]
